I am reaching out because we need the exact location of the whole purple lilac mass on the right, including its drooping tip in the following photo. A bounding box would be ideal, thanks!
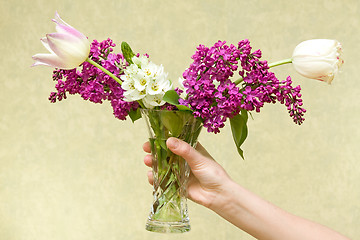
[181,40,305,133]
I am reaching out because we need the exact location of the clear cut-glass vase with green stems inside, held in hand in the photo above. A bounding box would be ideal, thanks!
[141,109,202,233]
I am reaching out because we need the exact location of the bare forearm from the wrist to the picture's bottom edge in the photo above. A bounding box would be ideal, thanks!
[211,181,348,240]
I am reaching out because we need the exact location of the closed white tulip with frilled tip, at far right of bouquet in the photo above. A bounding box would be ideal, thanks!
[292,39,344,84]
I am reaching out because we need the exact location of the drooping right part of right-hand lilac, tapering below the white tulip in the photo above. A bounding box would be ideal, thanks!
[238,39,306,125]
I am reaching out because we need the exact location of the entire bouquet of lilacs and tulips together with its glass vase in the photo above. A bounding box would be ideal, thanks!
[33,13,343,232]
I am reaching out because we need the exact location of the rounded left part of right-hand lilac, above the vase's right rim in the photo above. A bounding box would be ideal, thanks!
[183,41,242,133]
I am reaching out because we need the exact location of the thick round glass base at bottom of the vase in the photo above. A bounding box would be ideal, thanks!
[145,220,191,233]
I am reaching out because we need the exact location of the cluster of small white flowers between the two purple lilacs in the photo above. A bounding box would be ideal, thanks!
[121,56,172,109]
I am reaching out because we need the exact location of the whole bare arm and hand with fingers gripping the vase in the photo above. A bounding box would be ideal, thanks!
[144,138,348,240]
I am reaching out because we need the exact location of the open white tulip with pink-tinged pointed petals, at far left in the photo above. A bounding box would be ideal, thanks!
[32,12,90,69]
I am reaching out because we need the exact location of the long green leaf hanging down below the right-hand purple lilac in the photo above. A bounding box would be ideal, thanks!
[230,110,248,159]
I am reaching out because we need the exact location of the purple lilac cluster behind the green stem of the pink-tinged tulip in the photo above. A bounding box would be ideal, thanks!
[49,39,139,120]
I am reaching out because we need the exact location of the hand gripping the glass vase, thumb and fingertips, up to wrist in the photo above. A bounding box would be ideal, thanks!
[143,138,231,209]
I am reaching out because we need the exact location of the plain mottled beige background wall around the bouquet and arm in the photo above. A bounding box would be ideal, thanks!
[0,0,360,240]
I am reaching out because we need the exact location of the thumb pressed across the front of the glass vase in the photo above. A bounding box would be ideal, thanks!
[166,137,213,171]
